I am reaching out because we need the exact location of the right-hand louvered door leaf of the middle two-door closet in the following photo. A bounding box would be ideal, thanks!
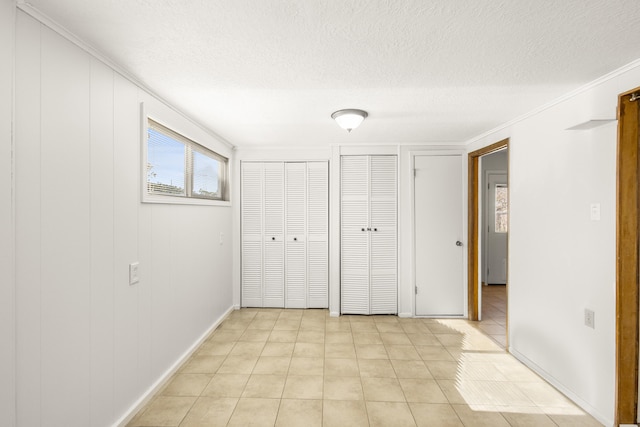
[369,156,398,314]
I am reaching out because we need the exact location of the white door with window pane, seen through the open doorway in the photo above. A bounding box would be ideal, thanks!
[485,173,508,285]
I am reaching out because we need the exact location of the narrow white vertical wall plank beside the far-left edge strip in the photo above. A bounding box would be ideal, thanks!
[15,13,42,425]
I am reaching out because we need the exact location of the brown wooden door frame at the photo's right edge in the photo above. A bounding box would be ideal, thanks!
[615,87,640,425]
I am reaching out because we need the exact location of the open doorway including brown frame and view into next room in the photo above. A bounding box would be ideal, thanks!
[467,139,509,348]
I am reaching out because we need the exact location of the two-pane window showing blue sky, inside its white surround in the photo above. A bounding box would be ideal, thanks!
[146,119,228,200]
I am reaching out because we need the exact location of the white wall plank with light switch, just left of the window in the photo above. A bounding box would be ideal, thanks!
[113,75,140,413]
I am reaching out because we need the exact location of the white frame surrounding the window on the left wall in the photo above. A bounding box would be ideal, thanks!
[140,103,231,206]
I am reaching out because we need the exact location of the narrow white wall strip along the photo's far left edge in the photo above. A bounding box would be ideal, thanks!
[0,0,15,426]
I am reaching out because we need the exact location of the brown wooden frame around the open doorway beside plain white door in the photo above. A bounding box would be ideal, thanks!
[467,138,509,320]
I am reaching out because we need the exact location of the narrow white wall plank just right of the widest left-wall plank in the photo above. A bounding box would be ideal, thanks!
[89,60,115,426]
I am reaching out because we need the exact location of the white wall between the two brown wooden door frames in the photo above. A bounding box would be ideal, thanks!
[469,63,640,425]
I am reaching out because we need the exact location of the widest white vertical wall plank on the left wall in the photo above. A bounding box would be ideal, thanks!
[41,27,91,426]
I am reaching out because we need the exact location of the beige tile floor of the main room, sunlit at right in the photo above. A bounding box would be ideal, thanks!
[128,309,600,427]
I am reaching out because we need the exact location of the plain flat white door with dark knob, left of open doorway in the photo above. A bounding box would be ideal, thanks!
[414,155,465,316]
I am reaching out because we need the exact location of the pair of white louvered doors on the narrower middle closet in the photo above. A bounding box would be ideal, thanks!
[340,156,398,314]
